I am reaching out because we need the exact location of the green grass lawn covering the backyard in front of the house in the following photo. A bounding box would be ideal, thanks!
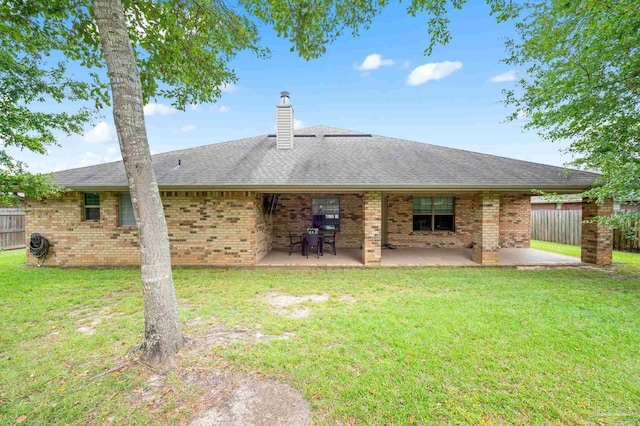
[0,248,640,425]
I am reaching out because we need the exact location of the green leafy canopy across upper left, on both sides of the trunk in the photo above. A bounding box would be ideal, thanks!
[0,0,515,203]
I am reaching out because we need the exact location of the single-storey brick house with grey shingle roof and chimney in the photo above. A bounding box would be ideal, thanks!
[25,93,611,266]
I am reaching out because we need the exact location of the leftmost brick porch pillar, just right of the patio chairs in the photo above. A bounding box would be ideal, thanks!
[362,192,382,266]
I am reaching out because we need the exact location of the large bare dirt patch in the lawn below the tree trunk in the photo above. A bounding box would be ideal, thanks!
[122,327,311,426]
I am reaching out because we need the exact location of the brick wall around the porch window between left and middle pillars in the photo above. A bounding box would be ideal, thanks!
[387,194,474,248]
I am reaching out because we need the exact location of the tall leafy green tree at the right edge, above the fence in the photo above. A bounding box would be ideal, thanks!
[506,0,640,231]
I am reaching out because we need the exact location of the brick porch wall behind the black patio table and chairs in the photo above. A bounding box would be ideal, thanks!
[273,194,362,248]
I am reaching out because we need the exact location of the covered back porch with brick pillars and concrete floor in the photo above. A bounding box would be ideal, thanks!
[255,191,612,267]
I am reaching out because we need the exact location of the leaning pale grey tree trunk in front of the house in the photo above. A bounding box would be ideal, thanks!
[92,0,184,364]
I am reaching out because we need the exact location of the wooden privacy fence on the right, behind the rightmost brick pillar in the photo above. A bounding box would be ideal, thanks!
[531,210,640,253]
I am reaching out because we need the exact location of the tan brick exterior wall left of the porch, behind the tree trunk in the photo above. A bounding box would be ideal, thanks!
[26,191,272,266]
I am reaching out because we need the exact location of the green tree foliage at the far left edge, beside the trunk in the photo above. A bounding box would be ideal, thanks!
[0,16,97,205]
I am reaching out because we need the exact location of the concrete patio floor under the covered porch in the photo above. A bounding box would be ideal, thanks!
[258,248,583,267]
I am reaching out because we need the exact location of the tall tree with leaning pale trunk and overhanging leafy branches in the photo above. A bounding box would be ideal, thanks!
[0,0,514,363]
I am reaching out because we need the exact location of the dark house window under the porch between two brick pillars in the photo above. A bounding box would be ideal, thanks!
[413,197,454,231]
